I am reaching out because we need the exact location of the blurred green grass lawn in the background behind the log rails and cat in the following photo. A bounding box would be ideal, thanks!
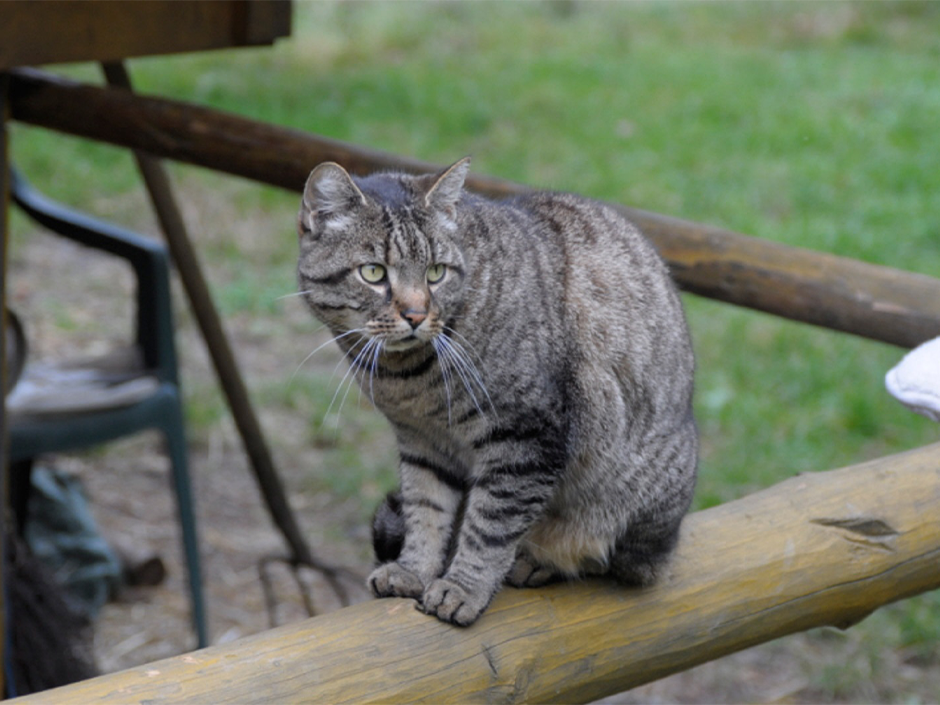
[13,1,940,701]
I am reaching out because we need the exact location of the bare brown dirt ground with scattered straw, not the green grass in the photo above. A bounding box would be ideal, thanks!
[10,179,940,703]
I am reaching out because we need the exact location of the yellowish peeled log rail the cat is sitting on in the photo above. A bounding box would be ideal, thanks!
[14,444,940,704]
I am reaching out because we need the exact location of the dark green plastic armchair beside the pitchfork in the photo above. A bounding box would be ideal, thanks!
[7,172,208,648]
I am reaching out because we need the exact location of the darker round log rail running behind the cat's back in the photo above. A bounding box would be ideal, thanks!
[11,71,940,348]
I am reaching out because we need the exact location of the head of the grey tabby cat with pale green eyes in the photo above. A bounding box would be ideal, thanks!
[298,158,470,353]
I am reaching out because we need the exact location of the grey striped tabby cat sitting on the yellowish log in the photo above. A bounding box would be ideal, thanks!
[298,159,697,625]
